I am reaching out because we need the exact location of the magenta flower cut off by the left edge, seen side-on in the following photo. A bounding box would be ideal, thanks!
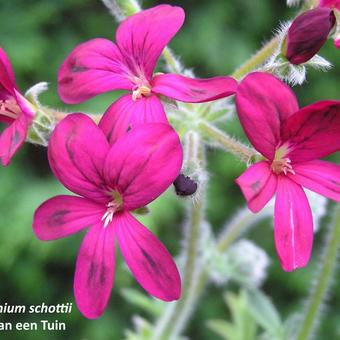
[0,48,35,166]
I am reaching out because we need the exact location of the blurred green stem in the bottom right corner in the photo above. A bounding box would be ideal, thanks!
[297,205,340,340]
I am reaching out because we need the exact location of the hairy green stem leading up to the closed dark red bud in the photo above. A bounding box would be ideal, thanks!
[231,36,280,80]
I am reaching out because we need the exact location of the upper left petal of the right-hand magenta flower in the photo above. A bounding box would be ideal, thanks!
[236,72,299,160]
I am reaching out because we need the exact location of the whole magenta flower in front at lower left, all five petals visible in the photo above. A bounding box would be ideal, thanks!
[33,114,182,318]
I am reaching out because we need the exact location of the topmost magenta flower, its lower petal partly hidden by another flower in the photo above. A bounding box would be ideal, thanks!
[58,5,237,133]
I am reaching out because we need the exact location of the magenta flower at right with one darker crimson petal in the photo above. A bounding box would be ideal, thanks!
[236,72,340,271]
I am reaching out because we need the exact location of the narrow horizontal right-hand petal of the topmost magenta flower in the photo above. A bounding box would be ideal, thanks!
[152,74,237,103]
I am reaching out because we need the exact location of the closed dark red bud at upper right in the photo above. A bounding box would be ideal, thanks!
[284,8,335,65]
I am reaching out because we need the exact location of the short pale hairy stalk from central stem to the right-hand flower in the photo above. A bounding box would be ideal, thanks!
[198,121,257,164]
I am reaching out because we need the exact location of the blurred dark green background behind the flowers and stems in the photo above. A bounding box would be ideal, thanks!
[0,0,340,340]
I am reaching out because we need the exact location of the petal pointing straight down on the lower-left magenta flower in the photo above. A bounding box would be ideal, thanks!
[74,223,115,319]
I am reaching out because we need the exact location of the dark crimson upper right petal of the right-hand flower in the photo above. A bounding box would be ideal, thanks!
[282,100,340,163]
